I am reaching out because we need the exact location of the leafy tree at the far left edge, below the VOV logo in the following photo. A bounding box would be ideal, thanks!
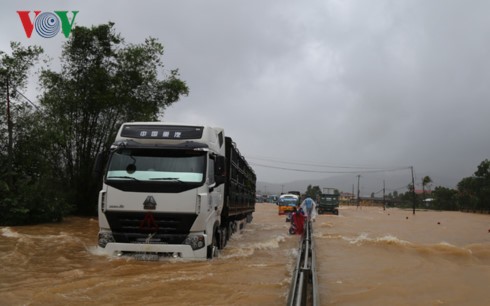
[0,42,63,225]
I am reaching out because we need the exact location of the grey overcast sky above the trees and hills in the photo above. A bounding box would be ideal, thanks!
[0,0,490,191]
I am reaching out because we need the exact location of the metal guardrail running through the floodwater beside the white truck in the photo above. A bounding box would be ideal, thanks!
[287,220,320,306]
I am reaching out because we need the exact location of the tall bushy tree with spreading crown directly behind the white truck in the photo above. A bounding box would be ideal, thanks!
[41,23,188,214]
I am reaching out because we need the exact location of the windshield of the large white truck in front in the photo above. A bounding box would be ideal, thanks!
[106,148,206,183]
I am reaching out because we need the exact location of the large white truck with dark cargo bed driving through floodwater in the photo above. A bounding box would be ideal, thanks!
[97,122,256,260]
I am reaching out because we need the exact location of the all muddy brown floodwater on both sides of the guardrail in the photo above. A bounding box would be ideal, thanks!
[0,204,490,305]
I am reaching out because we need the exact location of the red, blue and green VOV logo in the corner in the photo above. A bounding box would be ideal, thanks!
[17,11,78,38]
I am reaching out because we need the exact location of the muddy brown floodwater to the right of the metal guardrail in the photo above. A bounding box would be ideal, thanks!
[315,207,490,305]
